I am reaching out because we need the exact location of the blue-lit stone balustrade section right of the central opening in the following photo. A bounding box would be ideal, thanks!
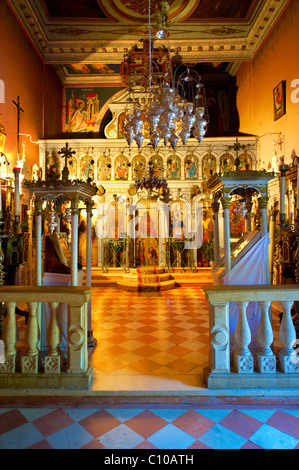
[202,284,299,389]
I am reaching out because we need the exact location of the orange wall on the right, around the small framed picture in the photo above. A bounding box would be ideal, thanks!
[237,0,299,166]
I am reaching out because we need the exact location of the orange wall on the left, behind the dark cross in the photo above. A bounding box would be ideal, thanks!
[0,0,62,170]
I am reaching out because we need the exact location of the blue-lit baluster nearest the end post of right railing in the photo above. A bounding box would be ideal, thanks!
[235,302,253,373]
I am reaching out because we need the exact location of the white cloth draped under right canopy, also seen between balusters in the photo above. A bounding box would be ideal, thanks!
[223,233,270,352]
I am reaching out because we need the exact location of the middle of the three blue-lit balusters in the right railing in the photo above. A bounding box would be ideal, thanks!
[257,301,276,373]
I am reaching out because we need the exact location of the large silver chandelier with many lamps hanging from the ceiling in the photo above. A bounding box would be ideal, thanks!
[124,0,208,150]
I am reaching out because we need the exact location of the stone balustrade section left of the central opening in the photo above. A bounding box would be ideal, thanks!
[0,286,92,389]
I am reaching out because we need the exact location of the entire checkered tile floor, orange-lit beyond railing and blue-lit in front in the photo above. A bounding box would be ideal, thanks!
[0,285,299,449]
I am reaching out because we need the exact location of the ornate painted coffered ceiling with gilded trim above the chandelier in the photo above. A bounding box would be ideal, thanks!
[8,0,289,83]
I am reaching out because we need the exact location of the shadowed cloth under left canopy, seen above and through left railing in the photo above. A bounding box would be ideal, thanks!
[41,269,84,355]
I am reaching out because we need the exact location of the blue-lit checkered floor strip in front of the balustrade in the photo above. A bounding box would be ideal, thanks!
[0,406,299,449]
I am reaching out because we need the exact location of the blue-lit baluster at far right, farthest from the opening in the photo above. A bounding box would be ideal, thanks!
[278,301,299,374]
